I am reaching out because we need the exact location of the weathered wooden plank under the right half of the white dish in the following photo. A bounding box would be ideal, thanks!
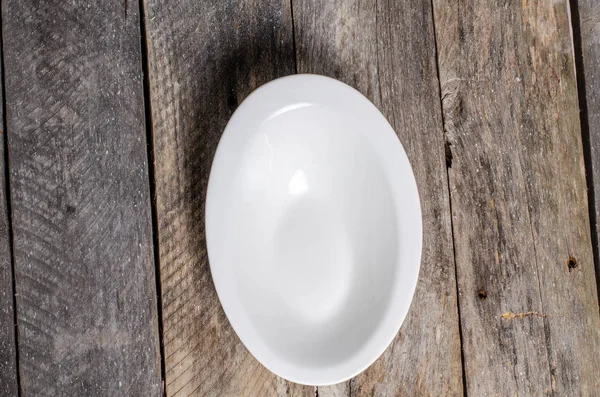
[293,0,463,396]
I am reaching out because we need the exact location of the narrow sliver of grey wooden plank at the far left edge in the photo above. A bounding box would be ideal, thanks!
[0,34,19,396]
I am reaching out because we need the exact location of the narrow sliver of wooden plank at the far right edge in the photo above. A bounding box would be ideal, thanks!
[572,0,600,300]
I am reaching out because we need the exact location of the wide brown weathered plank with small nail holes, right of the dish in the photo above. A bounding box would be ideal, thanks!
[433,0,600,396]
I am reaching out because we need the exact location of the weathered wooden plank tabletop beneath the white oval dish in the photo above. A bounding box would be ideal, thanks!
[0,0,600,397]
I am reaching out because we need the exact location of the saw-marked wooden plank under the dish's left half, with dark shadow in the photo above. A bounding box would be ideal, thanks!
[144,0,314,396]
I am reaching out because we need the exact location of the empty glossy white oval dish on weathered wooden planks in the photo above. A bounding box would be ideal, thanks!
[206,74,422,385]
